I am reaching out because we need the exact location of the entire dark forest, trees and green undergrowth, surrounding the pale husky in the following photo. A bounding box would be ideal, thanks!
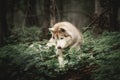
[0,0,120,80]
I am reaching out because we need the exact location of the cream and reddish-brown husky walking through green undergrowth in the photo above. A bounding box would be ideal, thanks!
[47,22,83,67]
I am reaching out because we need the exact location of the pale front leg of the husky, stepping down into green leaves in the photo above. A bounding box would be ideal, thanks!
[56,49,64,68]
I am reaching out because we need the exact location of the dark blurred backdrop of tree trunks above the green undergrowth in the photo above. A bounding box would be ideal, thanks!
[0,0,120,46]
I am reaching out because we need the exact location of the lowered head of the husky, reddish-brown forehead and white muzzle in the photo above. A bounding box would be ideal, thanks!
[49,28,72,49]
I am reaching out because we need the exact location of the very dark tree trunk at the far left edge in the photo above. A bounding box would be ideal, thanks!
[0,0,9,46]
